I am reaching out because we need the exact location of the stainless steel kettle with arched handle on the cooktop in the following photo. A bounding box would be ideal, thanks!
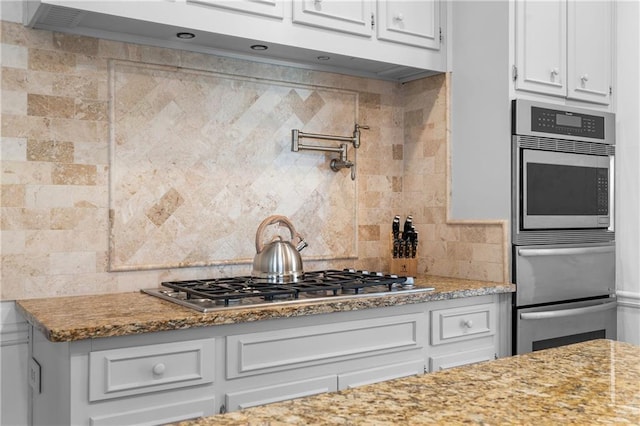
[251,215,307,283]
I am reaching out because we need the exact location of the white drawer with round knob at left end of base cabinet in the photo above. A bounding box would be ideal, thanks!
[89,339,215,401]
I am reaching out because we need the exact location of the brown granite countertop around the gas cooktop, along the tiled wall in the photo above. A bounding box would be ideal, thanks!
[16,276,515,342]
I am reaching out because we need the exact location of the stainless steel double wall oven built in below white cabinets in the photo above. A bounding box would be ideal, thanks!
[512,99,616,354]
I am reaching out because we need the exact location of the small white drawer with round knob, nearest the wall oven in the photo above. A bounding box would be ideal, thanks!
[431,303,496,345]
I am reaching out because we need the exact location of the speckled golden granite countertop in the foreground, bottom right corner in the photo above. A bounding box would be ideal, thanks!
[178,340,640,426]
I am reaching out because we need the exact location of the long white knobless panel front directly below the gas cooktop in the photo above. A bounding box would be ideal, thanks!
[227,313,427,379]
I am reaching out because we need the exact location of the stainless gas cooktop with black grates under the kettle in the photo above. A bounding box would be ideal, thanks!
[141,269,433,312]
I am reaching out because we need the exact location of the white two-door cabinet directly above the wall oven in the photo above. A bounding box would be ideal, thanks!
[514,0,613,105]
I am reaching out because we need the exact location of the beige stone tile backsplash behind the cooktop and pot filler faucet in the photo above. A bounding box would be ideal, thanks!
[0,22,508,300]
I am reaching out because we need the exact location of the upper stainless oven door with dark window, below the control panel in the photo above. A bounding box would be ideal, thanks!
[522,150,609,229]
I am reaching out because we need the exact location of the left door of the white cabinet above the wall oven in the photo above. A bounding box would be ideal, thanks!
[515,0,567,97]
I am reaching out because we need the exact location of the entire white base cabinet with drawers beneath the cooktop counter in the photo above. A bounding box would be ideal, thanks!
[29,295,508,426]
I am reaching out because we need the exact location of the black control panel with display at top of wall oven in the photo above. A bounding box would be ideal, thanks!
[531,107,604,139]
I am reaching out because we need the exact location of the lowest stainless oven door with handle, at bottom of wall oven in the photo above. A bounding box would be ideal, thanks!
[516,297,617,354]
